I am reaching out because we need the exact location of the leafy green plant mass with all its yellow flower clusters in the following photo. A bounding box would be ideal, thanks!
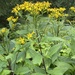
[0,1,75,75]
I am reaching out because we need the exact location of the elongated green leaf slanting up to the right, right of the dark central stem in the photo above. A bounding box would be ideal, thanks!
[47,43,61,58]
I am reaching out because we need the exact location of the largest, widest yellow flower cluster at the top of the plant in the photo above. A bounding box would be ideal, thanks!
[12,1,51,15]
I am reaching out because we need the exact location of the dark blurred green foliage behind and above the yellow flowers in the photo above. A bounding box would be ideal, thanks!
[0,0,75,27]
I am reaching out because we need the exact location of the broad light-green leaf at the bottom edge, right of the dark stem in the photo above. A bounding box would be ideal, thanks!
[48,61,71,75]
